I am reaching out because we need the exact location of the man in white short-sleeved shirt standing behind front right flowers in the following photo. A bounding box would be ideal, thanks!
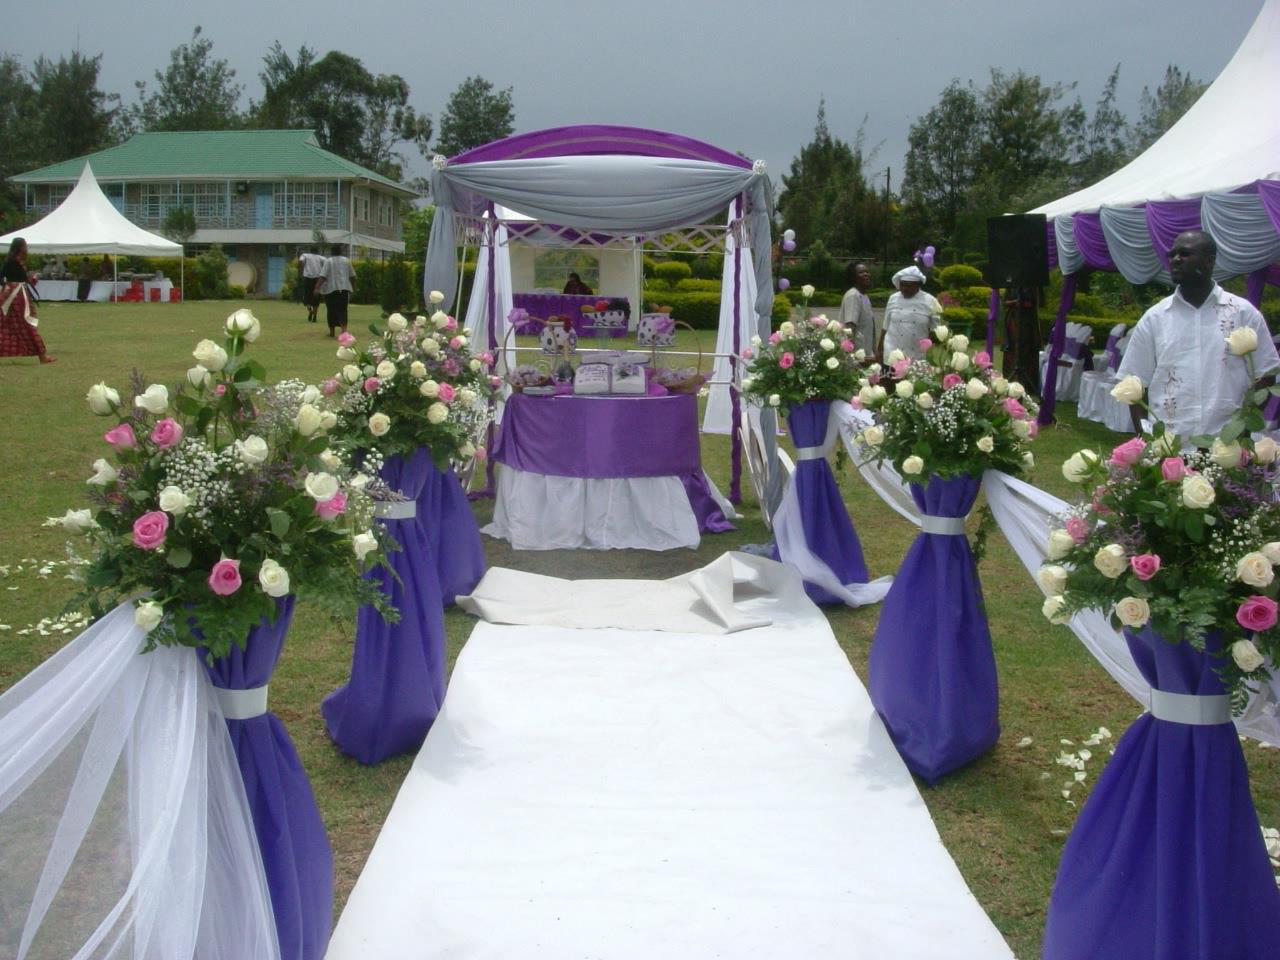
[1117,230,1280,442]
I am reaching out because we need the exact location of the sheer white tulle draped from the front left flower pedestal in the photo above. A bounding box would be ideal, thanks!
[0,604,280,960]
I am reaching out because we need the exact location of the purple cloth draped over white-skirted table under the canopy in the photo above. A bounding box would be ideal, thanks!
[490,393,733,534]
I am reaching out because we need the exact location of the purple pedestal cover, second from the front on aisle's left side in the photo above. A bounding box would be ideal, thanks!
[320,449,444,764]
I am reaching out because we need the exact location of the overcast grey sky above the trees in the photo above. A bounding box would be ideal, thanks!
[0,0,1262,189]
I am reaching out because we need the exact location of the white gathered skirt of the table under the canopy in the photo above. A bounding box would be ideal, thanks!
[483,466,699,550]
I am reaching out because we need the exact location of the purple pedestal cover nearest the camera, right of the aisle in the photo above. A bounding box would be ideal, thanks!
[1043,627,1280,960]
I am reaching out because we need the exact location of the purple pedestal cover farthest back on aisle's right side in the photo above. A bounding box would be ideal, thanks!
[773,401,870,604]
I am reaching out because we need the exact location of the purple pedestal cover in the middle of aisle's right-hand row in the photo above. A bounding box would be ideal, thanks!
[867,476,1000,785]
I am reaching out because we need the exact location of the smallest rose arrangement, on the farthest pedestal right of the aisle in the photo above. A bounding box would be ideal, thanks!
[742,316,865,408]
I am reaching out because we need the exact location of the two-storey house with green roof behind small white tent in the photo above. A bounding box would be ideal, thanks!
[12,131,417,293]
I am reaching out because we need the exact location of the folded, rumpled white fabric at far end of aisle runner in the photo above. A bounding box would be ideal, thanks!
[458,553,788,634]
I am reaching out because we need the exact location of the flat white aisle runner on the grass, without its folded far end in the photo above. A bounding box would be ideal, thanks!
[328,561,1012,960]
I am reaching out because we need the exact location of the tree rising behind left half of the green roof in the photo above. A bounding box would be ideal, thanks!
[133,27,243,131]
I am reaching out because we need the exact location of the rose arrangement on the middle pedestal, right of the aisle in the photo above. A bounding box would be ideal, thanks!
[851,326,1039,480]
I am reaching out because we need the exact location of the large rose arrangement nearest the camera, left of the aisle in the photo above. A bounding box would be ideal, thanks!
[52,310,394,658]
